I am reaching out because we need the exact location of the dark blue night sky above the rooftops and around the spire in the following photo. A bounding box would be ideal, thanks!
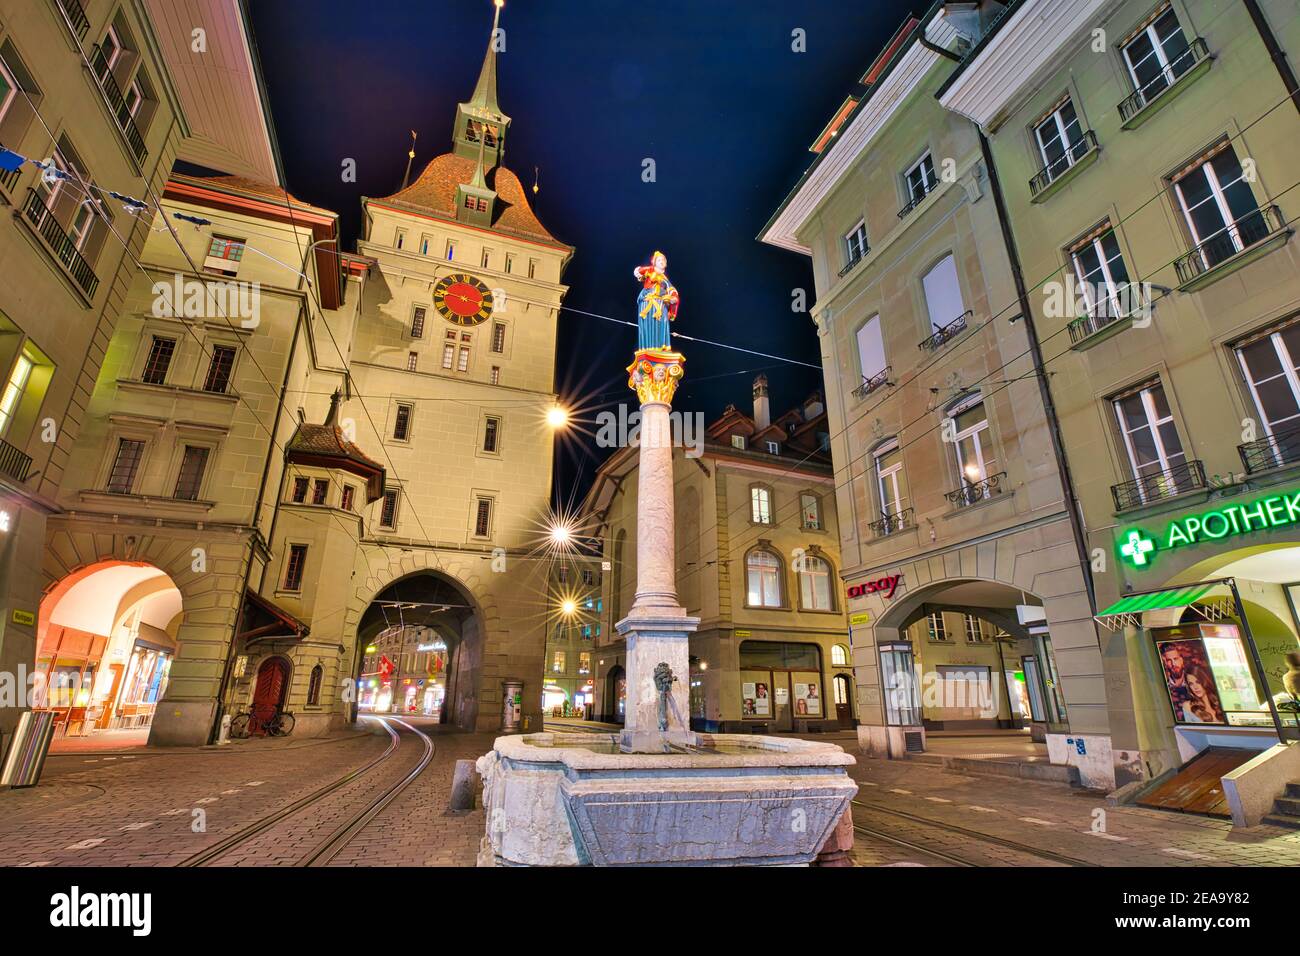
[250,0,926,499]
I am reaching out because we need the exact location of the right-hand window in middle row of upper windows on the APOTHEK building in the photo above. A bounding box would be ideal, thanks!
[1174,144,1269,269]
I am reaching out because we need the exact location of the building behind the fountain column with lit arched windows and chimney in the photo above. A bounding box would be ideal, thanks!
[582,375,857,734]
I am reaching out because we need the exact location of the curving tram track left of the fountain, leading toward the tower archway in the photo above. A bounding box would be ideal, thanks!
[177,717,434,866]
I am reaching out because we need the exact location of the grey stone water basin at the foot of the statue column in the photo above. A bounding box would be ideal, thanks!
[477,734,858,866]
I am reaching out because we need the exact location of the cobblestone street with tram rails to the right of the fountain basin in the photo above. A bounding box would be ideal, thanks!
[850,750,1300,866]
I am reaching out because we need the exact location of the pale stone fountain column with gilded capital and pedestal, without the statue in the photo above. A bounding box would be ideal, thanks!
[615,349,699,753]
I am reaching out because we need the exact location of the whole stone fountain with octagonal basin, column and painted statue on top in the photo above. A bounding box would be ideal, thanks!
[477,252,858,866]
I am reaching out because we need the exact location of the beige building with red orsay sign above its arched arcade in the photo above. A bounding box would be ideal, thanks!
[759,5,1109,780]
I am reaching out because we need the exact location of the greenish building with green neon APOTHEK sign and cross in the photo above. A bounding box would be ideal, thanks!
[939,0,1300,813]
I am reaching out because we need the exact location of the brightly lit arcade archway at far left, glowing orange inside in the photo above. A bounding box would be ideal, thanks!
[34,561,183,749]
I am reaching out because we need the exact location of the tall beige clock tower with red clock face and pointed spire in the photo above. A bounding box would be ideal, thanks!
[340,0,573,730]
